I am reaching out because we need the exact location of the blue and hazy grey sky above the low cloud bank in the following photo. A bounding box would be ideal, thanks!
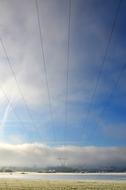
[0,0,126,165]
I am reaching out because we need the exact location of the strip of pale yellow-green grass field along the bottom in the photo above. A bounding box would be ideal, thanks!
[0,179,126,190]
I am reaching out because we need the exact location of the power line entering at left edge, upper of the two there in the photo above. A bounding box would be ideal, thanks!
[0,38,38,140]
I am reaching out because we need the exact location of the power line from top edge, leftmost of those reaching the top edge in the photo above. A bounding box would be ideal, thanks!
[35,0,56,140]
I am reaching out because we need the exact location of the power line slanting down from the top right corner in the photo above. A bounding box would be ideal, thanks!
[83,0,122,137]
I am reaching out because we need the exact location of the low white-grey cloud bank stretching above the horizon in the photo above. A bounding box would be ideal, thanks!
[0,143,126,167]
